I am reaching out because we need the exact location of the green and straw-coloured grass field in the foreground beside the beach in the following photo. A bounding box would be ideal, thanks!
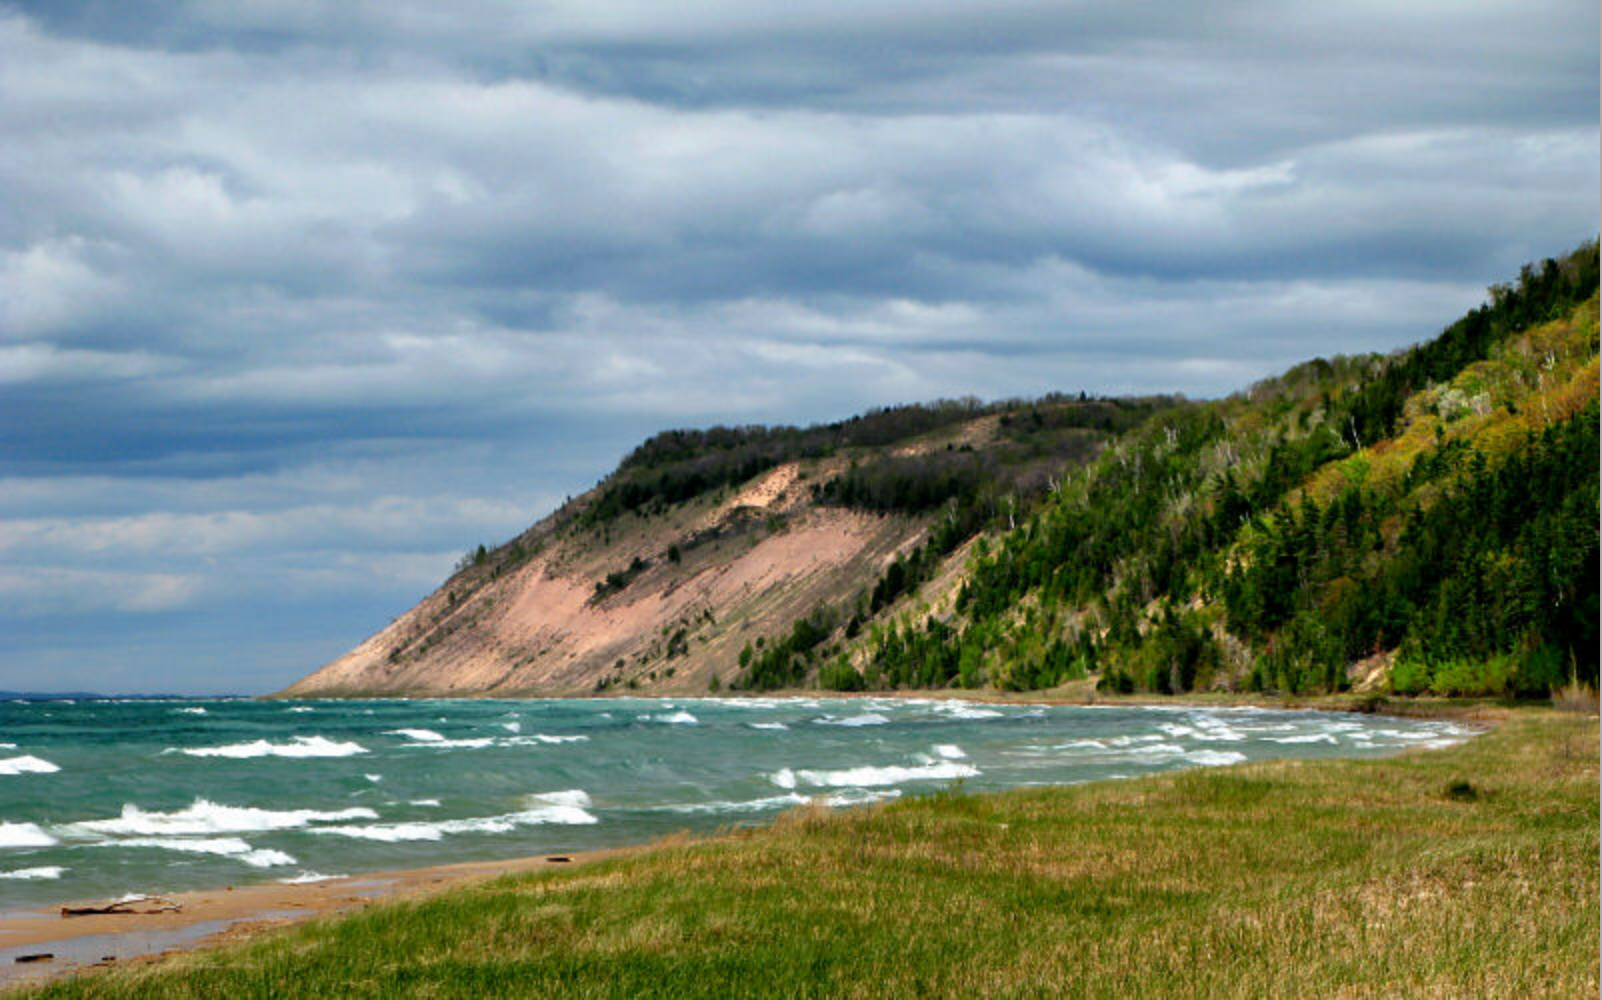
[38,710,1599,998]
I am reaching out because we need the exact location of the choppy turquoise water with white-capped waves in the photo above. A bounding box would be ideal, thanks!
[0,699,1469,910]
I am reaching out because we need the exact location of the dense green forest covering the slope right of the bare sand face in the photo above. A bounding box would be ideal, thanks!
[730,244,1599,694]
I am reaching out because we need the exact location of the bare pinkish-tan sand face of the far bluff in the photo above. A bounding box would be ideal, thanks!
[287,490,921,697]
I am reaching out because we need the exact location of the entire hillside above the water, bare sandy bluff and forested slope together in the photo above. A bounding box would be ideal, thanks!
[285,245,1599,696]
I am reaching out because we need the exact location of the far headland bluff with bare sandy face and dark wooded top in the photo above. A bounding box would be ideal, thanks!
[284,396,1177,696]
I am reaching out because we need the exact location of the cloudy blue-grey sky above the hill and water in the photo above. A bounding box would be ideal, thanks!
[0,0,1602,694]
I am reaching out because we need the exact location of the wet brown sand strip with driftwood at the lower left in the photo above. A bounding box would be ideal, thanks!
[0,848,641,990]
